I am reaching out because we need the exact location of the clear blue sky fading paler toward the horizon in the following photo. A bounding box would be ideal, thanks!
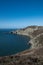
[0,0,43,28]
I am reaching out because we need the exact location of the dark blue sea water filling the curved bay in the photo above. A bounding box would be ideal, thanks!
[0,29,30,56]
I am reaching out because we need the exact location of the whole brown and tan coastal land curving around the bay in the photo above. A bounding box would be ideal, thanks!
[0,26,43,65]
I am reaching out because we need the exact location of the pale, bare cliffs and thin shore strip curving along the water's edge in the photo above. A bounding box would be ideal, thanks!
[0,27,42,56]
